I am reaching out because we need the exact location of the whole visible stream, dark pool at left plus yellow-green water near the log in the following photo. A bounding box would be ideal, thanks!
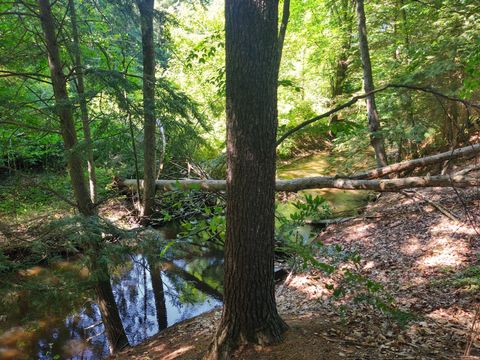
[0,153,369,360]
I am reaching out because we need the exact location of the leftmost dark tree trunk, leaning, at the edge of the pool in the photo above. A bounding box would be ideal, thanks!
[38,0,94,216]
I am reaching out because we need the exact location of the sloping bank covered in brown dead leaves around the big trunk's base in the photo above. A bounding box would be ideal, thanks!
[115,184,480,360]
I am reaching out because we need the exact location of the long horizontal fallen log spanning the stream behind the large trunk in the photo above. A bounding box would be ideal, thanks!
[122,175,480,192]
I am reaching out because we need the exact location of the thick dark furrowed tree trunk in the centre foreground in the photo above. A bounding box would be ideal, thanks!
[206,0,287,359]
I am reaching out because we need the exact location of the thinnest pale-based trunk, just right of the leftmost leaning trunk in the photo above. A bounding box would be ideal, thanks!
[68,0,97,203]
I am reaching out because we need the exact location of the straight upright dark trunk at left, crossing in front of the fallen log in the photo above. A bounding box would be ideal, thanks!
[137,0,155,217]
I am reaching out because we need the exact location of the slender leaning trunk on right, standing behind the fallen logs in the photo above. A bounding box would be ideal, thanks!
[357,0,387,167]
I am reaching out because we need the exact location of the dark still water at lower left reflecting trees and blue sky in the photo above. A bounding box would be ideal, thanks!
[0,250,223,359]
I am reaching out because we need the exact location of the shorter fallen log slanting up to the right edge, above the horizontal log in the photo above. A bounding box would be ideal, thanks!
[348,144,480,180]
